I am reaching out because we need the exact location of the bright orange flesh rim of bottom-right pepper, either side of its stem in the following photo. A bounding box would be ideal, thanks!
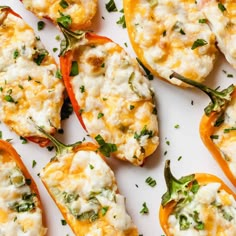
[159,173,236,236]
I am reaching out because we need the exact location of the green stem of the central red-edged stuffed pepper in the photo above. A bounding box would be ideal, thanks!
[58,23,86,56]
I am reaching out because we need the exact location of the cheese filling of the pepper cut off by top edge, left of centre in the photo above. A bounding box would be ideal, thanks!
[23,0,97,28]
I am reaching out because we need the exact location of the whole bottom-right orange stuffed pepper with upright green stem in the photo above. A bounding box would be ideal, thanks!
[159,160,236,236]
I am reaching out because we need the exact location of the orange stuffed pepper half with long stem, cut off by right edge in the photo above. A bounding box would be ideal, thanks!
[171,73,236,186]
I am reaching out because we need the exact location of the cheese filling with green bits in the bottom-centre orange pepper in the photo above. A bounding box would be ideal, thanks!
[40,151,134,235]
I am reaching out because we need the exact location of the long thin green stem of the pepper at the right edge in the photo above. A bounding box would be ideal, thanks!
[170,72,235,116]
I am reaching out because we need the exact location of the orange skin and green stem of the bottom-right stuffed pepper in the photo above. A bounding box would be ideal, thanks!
[159,160,236,236]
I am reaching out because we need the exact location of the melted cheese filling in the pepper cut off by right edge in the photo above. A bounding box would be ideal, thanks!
[212,97,236,178]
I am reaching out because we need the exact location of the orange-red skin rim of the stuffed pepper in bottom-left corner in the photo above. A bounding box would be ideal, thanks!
[0,140,47,236]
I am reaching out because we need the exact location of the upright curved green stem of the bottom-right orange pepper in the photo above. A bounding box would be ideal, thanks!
[161,160,195,207]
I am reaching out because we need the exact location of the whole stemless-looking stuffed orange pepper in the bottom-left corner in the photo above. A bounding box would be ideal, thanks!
[0,140,46,236]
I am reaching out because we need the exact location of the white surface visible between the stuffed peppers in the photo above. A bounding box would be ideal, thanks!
[0,0,236,236]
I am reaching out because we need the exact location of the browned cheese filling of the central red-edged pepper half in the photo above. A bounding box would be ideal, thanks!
[71,42,159,165]
